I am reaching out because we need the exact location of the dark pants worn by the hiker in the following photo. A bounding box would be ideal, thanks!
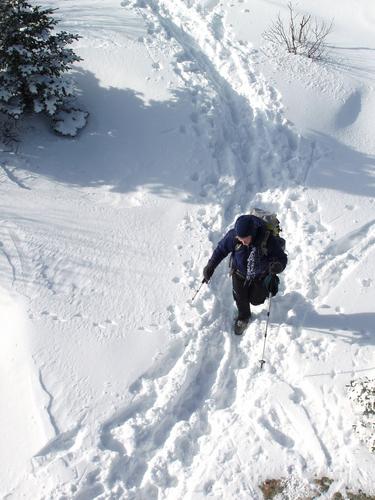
[232,272,268,321]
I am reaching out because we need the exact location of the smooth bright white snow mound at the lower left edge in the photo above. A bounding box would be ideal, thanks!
[0,288,48,498]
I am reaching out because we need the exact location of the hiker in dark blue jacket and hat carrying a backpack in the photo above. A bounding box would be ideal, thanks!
[203,215,287,335]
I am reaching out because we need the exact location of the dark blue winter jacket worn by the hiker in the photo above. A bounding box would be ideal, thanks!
[208,215,288,281]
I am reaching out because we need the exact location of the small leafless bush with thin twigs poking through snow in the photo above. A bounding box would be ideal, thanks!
[263,2,333,59]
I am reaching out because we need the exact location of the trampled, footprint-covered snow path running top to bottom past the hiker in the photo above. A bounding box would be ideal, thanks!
[0,0,374,500]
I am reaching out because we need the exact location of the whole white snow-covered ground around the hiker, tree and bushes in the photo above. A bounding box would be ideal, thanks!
[0,0,375,500]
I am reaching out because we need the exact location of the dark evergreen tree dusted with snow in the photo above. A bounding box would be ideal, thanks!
[0,0,87,135]
